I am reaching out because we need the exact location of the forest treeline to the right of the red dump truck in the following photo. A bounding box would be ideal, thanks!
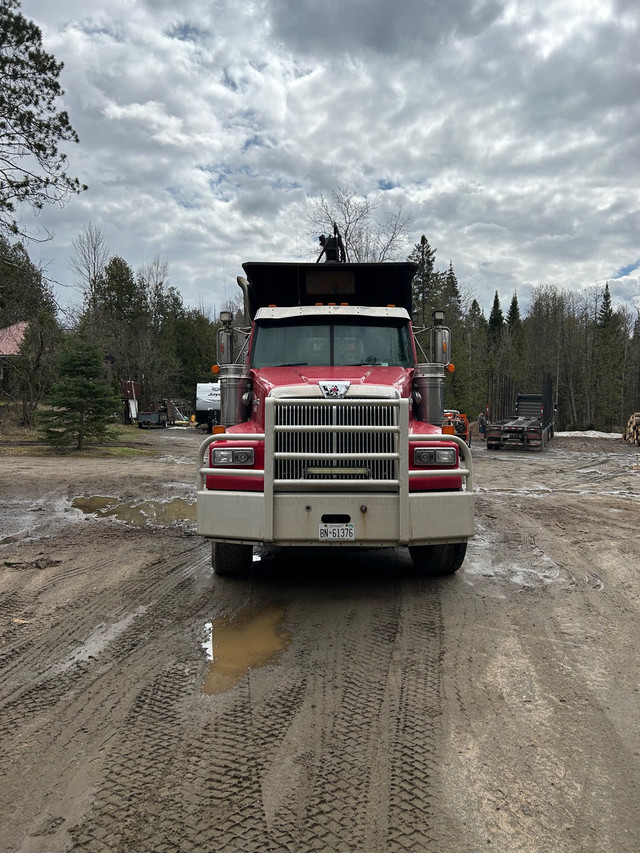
[410,237,640,432]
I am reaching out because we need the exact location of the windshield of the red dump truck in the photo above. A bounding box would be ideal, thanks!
[249,317,413,368]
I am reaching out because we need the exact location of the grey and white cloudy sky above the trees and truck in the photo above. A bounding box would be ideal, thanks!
[13,0,640,314]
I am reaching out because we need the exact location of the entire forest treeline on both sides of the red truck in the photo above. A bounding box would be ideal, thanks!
[0,226,640,431]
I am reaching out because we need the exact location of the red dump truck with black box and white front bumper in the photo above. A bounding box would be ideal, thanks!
[197,250,474,575]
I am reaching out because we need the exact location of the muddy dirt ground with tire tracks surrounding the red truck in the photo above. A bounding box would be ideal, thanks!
[0,430,640,853]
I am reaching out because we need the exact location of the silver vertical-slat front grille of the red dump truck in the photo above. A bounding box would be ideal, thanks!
[275,400,398,480]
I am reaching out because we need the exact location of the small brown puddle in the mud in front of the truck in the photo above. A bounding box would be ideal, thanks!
[202,604,291,696]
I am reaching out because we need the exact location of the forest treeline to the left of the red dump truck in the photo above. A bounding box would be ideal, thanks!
[0,226,218,426]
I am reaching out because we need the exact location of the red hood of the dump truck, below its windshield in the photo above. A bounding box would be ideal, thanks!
[251,365,413,397]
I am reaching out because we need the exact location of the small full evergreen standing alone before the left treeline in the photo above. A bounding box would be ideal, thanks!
[39,332,120,450]
